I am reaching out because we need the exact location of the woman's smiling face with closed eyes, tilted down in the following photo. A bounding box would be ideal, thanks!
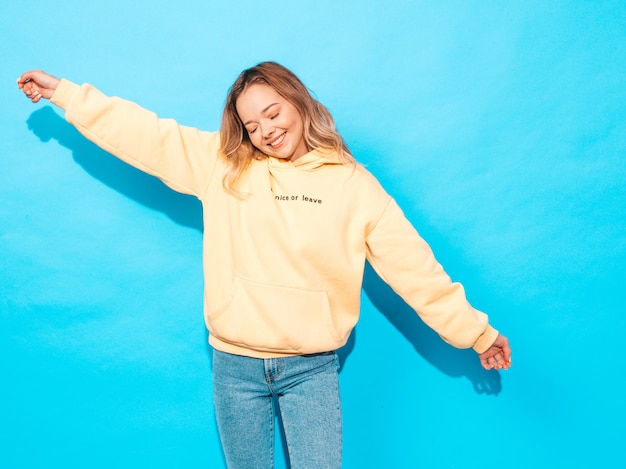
[236,83,309,161]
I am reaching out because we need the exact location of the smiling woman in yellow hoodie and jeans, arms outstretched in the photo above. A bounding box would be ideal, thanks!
[18,62,511,469]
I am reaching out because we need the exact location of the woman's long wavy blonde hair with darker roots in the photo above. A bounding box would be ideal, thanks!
[220,62,354,195]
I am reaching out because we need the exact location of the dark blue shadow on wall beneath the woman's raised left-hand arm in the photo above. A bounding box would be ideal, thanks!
[26,106,202,231]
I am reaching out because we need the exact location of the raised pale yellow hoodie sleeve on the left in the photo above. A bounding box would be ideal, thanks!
[51,79,219,198]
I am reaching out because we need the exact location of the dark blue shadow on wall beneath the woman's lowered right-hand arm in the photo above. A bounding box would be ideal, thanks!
[363,264,502,395]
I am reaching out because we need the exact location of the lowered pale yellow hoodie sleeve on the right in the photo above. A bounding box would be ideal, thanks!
[367,199,498,353]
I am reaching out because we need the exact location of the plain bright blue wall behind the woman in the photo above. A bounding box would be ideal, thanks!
[0,0,626,468]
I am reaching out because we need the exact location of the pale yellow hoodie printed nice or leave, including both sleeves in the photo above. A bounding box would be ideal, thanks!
[51,80,498,358]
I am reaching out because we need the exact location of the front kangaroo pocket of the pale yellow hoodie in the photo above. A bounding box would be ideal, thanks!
[208,277,342,353]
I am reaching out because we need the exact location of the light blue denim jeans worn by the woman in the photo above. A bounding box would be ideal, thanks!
[213,350,342,469]
